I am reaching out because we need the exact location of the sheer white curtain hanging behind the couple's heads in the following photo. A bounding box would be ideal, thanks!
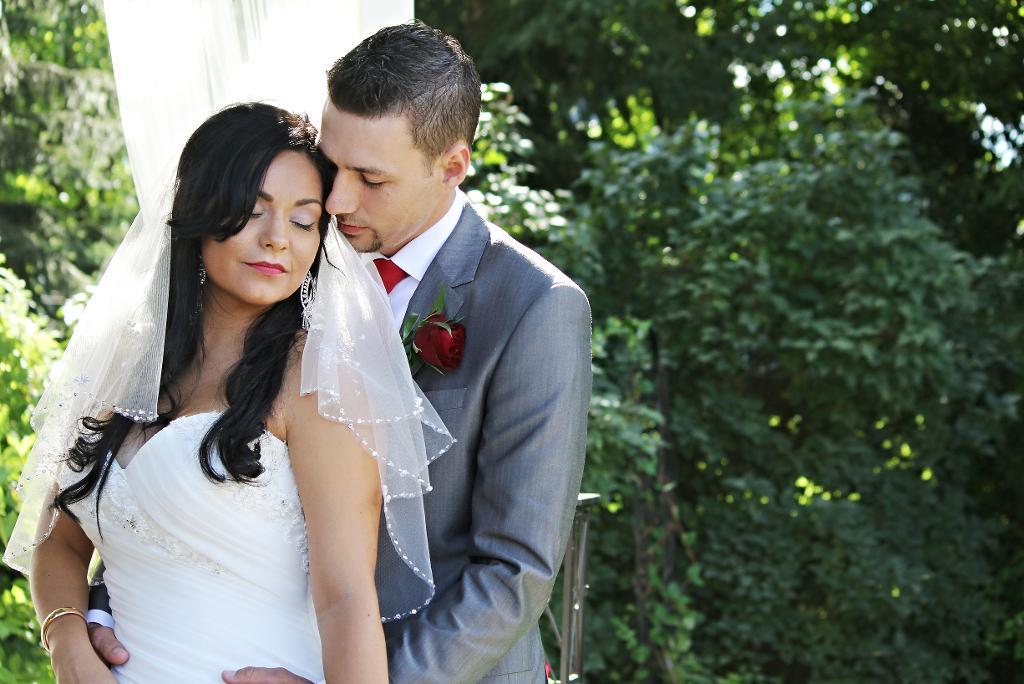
[103,0,413,212]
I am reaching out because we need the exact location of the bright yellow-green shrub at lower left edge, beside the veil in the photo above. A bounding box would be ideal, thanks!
[0,255,58,684]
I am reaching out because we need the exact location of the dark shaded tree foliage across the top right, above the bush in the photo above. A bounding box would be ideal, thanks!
[416,0,1024,254]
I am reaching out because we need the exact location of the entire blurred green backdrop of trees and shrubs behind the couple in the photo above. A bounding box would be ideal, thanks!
[0,0,1024,684]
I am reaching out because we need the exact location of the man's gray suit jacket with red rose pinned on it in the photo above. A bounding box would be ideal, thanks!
[378,205,591,684]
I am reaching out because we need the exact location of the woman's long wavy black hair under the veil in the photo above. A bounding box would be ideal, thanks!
[54,102,334,522]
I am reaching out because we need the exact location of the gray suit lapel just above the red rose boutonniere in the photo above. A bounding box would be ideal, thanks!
[406,202,489,377]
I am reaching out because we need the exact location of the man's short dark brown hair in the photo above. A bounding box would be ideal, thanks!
[328,22,480,160]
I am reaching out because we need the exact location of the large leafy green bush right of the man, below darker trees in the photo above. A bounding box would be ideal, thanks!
[462,74,1024,682]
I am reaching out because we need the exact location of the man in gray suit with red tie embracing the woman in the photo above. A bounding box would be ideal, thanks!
[93,24,591,684]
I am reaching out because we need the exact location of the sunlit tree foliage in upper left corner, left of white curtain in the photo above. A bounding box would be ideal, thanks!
[0,0,137,312]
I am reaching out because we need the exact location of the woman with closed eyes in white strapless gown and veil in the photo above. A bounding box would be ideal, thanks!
[4,103,451,683]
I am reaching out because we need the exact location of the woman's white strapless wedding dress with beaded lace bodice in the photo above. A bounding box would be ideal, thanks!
[63,413,324,684]
